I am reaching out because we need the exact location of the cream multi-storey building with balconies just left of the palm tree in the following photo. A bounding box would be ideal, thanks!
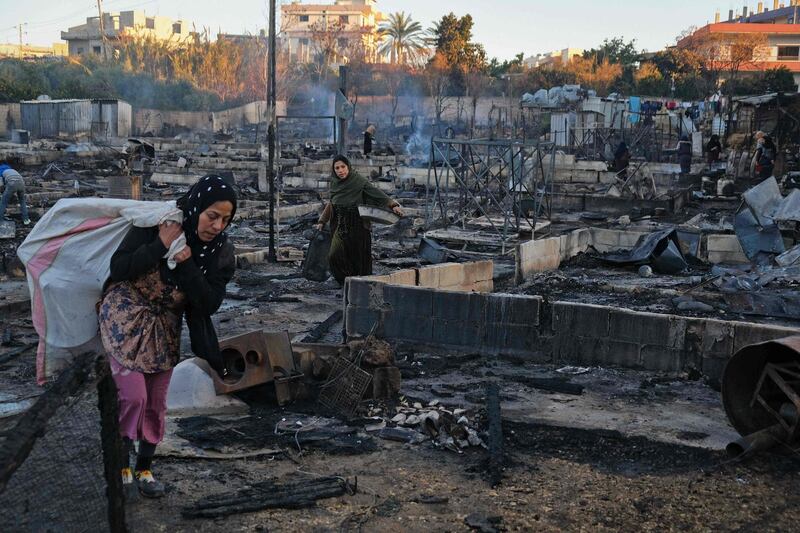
[281,0,385,64]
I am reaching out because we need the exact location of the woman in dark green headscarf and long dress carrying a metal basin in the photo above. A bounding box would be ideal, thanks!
[316,155,403,285]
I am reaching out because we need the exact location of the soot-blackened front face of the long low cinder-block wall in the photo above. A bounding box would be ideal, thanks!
[344,272,800,379]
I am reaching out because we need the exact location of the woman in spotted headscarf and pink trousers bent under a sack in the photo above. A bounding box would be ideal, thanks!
[99,176,236,498]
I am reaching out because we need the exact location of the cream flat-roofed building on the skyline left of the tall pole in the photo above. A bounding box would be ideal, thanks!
[61,11,192,56]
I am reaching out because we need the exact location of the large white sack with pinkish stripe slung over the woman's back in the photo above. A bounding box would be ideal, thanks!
[17,198,183,384]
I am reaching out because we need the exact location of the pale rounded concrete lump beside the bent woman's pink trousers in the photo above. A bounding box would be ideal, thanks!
[167,358,249,416]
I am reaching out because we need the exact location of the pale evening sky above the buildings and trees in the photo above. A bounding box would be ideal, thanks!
[0,0,724,60]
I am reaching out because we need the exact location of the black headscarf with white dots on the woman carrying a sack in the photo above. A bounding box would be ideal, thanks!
[177,175,236,275]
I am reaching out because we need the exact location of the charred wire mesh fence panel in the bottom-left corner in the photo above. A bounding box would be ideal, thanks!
[0,354,126,533]
